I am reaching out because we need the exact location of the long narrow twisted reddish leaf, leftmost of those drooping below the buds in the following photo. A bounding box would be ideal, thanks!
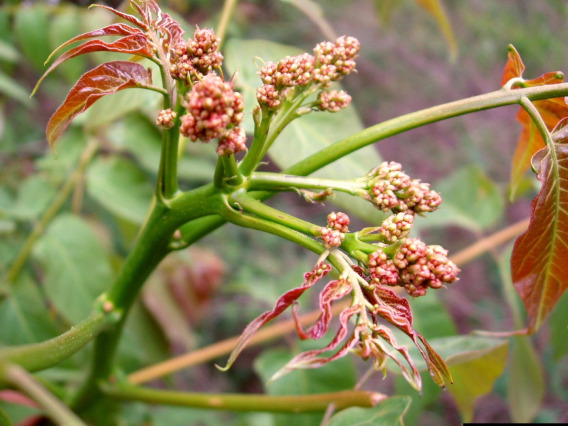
[217,262,331,371]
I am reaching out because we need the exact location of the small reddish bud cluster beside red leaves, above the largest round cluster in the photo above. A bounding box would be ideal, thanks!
[170,28,223,81]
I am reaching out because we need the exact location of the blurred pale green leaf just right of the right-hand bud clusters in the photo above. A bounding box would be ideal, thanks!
[416,165,504,231]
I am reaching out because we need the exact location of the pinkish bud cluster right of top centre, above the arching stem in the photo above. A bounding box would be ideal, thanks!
[257,36,360,111]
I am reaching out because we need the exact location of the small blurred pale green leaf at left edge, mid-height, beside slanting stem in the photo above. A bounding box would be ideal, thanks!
[0,174,56,220]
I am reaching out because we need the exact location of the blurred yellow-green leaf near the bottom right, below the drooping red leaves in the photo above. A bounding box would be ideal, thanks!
[448,341,509,422]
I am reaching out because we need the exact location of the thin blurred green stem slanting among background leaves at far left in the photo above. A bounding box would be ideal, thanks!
[6,139,99,282]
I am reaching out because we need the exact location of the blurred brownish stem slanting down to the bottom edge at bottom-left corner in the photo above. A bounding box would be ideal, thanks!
[5,365,86,426]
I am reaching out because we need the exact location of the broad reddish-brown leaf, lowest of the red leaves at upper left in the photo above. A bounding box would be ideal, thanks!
[47,61,152,146]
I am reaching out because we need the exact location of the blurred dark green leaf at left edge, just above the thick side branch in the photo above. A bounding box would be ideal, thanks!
[0,274,58,346]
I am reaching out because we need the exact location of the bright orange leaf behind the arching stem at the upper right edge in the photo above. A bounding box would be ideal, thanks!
[501,46,568,198]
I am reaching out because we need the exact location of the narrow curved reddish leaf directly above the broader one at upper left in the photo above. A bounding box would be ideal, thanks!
[34,30,154,92]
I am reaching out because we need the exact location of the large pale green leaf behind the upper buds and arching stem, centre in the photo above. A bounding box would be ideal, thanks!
[225,40,384,223]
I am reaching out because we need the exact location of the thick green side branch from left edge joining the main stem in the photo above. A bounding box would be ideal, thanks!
[0,309,111,382]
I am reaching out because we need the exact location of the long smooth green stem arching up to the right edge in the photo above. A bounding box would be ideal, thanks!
[284,83,568,175]
